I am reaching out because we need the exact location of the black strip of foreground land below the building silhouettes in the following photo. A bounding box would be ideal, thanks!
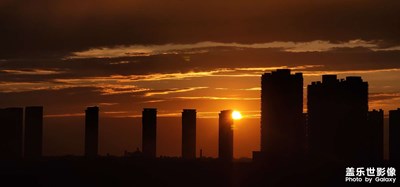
[0,157,400,187]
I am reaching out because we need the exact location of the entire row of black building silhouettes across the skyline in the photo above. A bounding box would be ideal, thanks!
[0,69,400,161]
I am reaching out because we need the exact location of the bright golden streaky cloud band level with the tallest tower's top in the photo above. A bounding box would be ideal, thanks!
[0,65,400,93]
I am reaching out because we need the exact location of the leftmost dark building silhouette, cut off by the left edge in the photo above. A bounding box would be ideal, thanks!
[0,108,23,159]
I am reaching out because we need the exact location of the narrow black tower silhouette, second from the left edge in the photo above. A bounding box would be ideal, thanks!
[24,106,43,158]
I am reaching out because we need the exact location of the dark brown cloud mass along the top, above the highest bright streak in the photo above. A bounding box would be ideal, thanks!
[0,0,400,58]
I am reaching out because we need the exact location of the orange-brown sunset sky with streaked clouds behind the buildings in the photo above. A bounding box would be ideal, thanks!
[0,0,400,158]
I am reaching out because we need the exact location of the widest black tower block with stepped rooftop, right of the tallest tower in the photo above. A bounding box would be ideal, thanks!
[307,75,370,160]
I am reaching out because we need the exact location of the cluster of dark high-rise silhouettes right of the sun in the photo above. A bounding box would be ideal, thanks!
[253,69,400,161]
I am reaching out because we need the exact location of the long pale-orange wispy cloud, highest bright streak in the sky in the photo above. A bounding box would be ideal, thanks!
[65,39,390,59]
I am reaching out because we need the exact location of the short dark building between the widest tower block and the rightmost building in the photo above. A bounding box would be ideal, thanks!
[365,109,384,161]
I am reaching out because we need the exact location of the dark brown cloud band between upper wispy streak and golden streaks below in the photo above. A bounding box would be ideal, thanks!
[0,48,400,85]
